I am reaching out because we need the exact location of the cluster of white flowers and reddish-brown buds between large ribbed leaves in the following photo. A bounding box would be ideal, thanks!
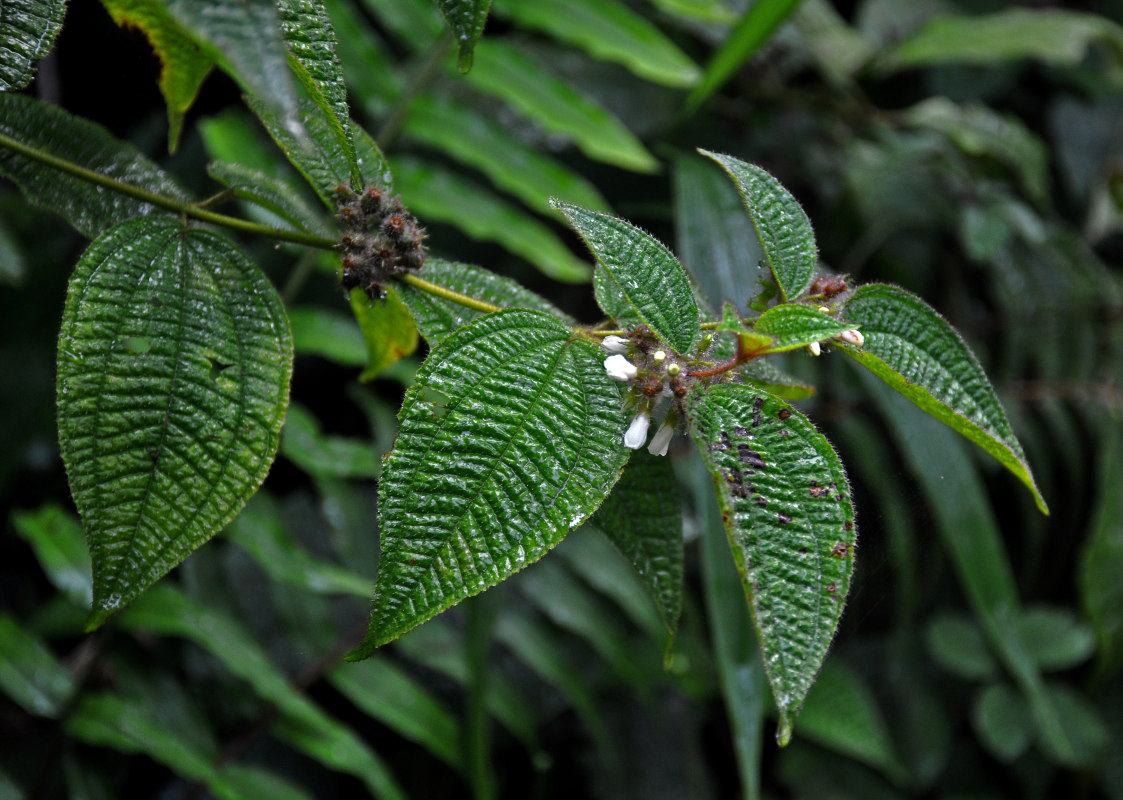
[601,328,691,455]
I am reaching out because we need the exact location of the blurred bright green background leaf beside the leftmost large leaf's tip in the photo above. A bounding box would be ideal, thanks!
[11,504,93,608]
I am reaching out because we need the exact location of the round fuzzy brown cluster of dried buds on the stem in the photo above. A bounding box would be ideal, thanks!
[334,184,426,298]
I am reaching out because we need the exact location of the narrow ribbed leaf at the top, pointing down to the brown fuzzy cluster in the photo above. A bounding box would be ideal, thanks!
[276,0,363,185]
